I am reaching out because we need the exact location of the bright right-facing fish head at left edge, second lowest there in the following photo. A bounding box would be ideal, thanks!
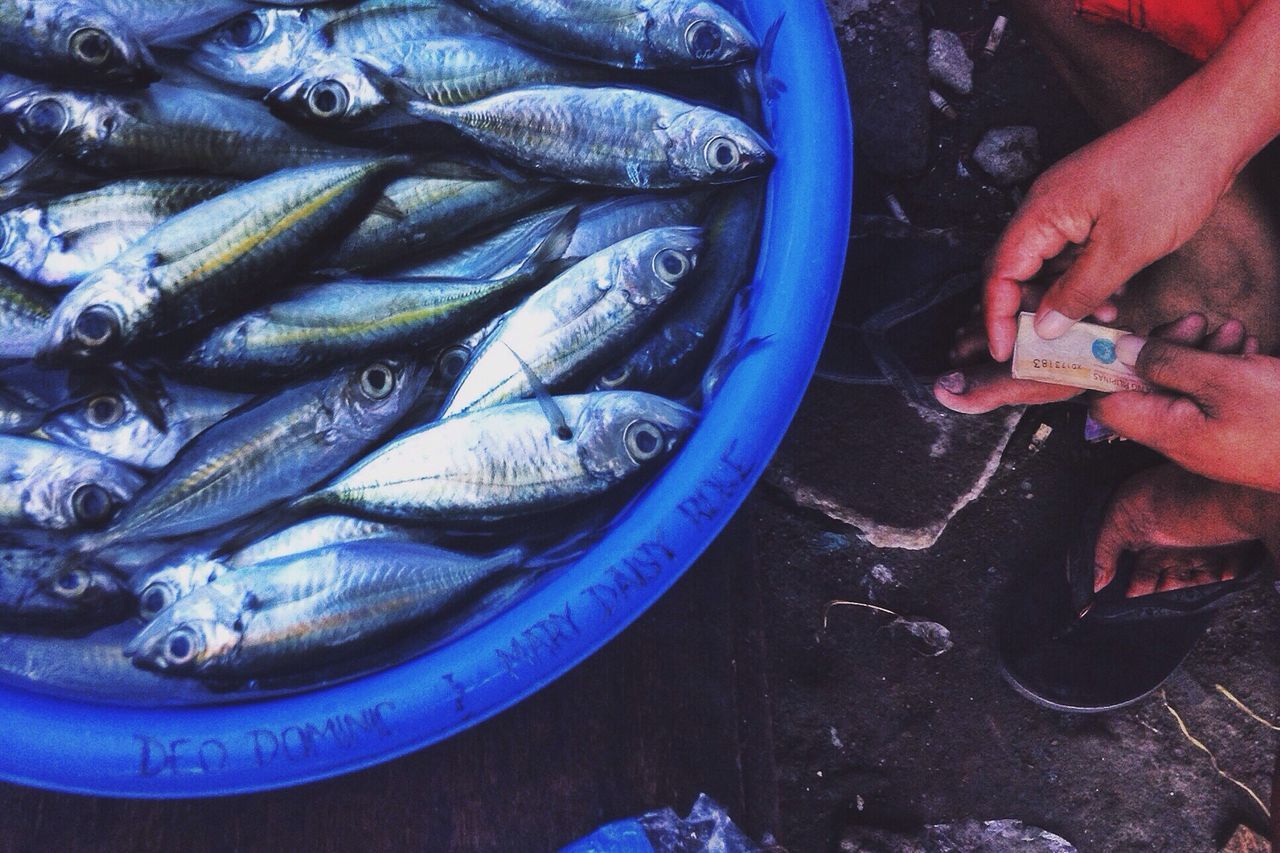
[22,448,145,530]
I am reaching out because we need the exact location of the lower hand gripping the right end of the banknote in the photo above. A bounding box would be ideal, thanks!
[1092,322,1280,492]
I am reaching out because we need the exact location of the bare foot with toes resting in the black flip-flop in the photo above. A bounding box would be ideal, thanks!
[1093,465,1280,598]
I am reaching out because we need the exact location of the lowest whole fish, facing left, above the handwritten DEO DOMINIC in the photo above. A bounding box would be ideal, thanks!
[124,540,526,679]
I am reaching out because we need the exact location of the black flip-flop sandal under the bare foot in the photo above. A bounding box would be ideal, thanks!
[1000,479,1266,713]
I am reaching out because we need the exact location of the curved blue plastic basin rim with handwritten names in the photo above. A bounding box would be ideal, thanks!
[0,0,852,798]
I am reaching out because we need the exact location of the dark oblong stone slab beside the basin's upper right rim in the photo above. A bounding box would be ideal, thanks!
[827,0,931,178]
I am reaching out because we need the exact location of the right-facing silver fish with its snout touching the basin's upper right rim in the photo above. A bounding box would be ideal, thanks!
[366,79,774,190]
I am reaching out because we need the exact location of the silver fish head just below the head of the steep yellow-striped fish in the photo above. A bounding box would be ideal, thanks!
[44,386,165,465]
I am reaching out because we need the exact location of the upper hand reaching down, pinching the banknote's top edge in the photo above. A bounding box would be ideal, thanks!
[983,97,1236,361]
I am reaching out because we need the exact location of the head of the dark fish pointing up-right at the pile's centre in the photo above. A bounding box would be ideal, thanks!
[325,359,431,438]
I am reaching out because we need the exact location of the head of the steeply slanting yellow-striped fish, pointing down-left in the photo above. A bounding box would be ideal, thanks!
[36,263,157,368]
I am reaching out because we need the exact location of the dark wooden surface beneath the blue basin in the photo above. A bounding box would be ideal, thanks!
[0,516,777,853]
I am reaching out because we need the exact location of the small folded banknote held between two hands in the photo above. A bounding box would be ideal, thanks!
[1014,311,1151,392]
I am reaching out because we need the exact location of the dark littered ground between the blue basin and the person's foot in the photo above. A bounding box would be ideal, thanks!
[750,0,1280,850]
